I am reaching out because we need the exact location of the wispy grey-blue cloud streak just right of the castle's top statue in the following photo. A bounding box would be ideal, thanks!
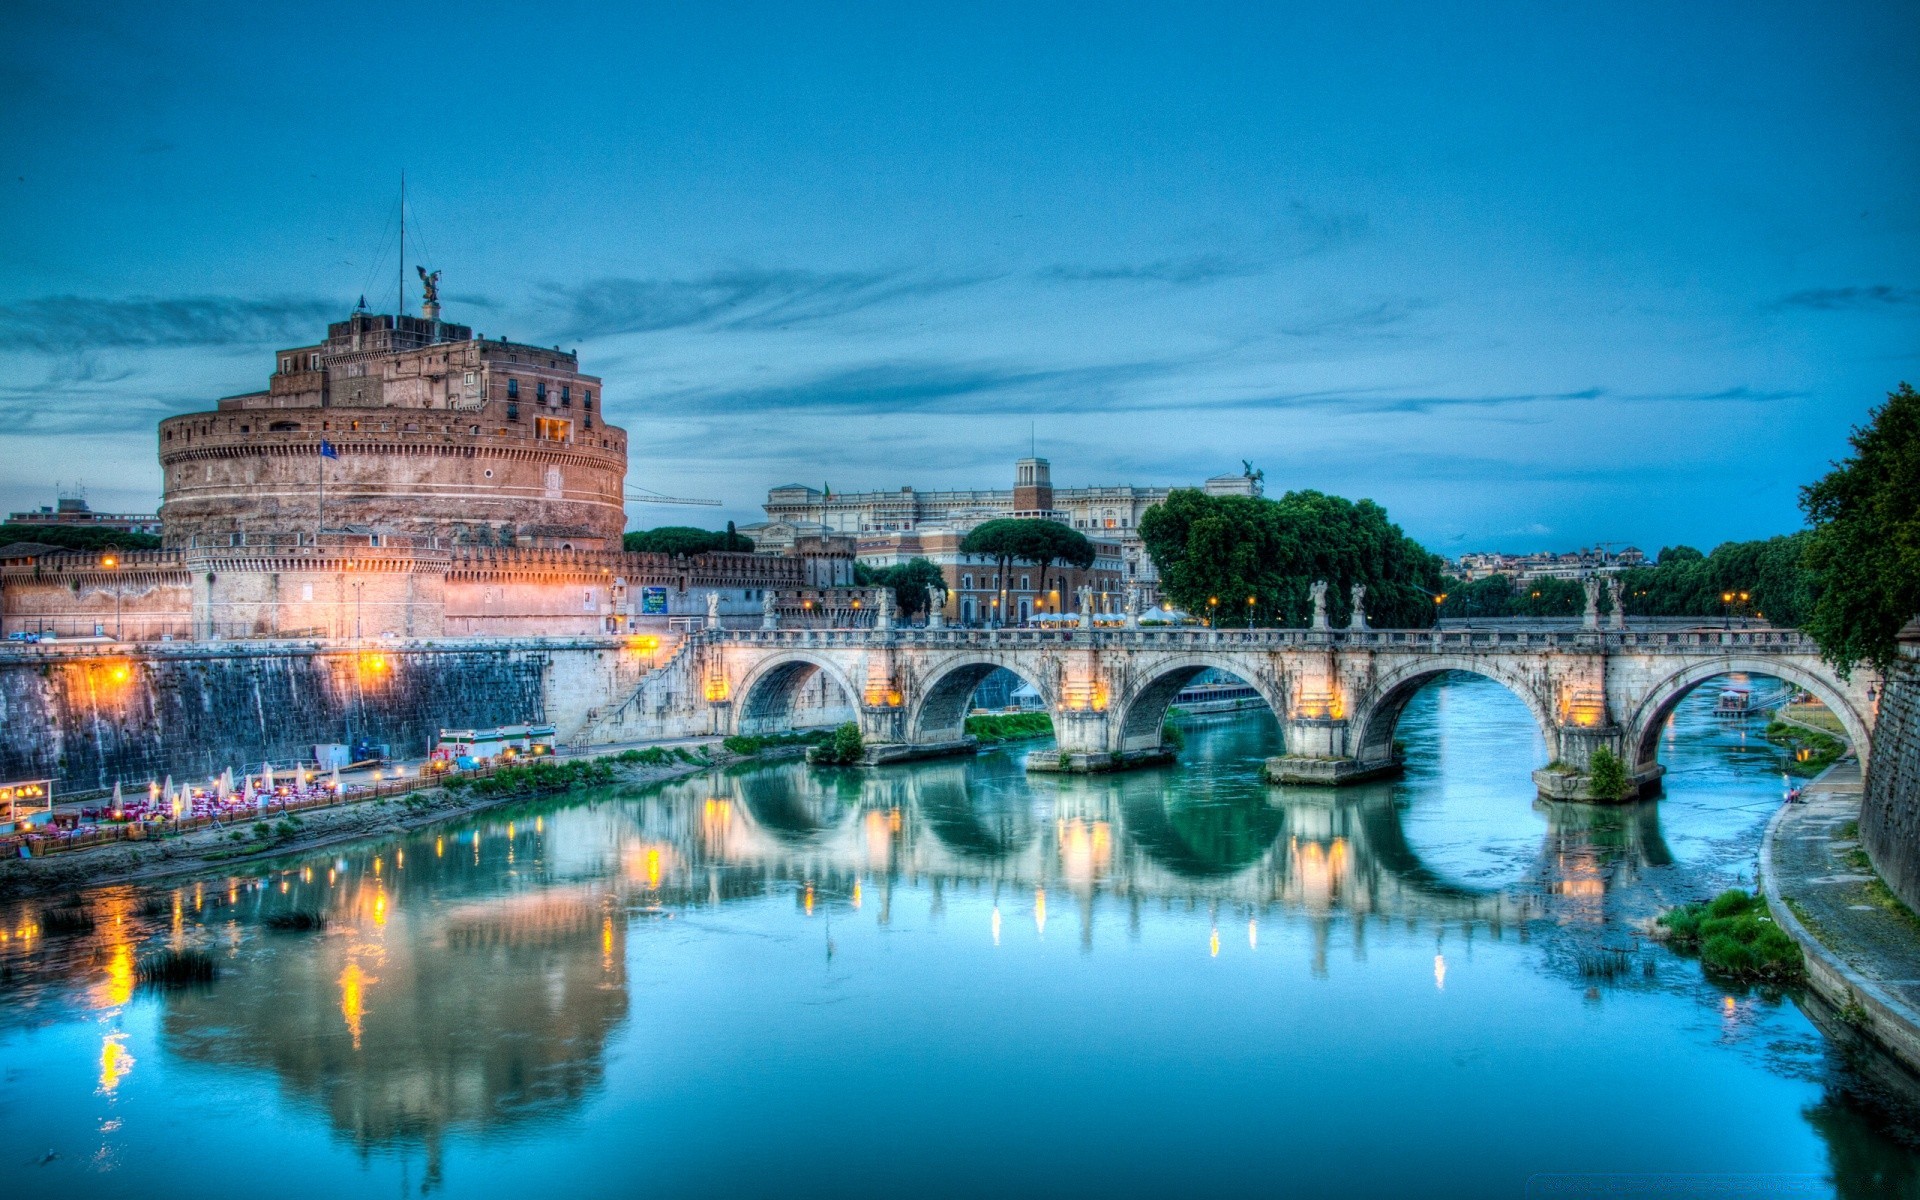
[541,267,991,340]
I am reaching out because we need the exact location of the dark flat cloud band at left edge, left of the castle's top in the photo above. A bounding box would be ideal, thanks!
[0,296,340,353]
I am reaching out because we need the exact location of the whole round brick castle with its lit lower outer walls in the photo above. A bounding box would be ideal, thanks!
[0,291,858,641]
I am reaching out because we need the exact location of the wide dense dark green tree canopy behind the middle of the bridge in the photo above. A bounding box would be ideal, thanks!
[1140,488,1440,628]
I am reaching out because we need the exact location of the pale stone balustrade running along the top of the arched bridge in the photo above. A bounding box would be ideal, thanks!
[705,626,1814,653]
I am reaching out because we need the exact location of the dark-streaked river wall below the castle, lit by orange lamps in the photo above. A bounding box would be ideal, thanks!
[0,637,668,797]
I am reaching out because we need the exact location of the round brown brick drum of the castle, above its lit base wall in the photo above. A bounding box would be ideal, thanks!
[159,303,626,549]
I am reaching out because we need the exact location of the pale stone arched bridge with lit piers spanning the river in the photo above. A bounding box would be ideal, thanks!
[588,628,1878,799]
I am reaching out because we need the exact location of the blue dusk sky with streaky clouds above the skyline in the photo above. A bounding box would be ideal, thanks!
[0,0,1920,555]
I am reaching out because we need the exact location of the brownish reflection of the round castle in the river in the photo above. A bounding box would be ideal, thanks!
[163,826,628,1181]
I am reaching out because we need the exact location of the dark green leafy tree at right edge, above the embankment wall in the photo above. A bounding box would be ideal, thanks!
[1801,384,1920,676]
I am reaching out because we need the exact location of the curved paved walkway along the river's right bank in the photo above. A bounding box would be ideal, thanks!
[1761,758,1920,1071]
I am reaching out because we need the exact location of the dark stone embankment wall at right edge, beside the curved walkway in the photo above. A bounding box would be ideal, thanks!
[1860,622,1920,910]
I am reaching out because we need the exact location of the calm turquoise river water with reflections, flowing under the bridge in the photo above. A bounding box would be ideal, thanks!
[0,676,1920,1198]
